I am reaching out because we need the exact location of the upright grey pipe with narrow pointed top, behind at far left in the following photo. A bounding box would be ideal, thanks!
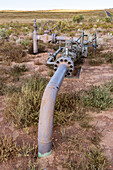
[33,19,38,54]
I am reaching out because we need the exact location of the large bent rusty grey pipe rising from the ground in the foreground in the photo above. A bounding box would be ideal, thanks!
[38,64,67,157]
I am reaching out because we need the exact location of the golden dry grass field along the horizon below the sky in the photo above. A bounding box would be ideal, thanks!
[0,10,106,23]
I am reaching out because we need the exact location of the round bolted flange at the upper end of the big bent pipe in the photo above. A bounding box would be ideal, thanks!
[54,57,74,77]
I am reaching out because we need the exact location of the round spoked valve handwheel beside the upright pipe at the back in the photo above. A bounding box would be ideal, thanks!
[43,21,59,35]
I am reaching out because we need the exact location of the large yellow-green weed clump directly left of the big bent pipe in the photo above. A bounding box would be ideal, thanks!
[6,75,47,128]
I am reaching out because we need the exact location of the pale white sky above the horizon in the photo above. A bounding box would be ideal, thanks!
[0,0,113,11]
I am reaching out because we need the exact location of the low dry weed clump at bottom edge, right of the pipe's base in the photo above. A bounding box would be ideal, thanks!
[59,134,109,170]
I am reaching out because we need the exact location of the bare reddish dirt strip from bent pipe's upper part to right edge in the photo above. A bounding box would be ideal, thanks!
[61,61,113,92]
